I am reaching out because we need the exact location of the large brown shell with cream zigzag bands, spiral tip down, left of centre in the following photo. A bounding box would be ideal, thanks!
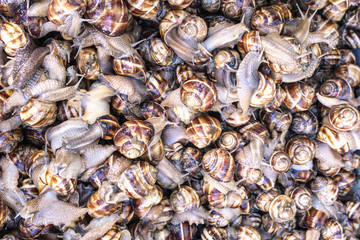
[114,120,154,159]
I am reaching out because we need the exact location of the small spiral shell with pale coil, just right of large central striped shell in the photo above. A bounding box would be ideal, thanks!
[216,130,245,153]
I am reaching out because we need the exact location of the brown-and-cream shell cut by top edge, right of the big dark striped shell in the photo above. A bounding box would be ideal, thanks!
[126,0,161,21]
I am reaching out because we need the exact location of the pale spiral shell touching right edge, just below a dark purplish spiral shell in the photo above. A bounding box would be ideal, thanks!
[328,104,360,131]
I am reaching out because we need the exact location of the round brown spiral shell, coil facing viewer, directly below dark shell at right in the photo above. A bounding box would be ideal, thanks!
[285,135,316,165]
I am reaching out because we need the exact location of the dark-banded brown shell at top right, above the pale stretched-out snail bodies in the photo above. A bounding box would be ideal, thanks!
[251,4,292,34]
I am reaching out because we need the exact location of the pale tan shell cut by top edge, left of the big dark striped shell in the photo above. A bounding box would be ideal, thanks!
[48,0,87,25]
